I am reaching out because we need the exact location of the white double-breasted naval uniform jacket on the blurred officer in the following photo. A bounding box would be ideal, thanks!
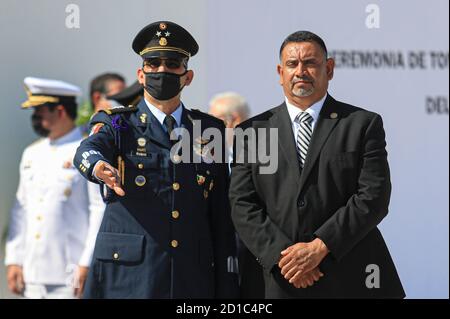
[5,128,105,296]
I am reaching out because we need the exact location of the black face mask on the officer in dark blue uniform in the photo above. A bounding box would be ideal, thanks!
[144,71,188,101]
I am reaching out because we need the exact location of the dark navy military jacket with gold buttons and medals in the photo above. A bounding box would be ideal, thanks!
[74,100,237,298]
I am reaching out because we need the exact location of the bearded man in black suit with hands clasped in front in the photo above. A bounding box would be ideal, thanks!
[229,31,405,298]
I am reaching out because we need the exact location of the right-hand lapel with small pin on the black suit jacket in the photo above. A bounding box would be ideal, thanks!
[294,95,339,193]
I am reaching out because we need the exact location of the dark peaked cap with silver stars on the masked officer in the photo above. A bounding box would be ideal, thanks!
[132,21,198,59]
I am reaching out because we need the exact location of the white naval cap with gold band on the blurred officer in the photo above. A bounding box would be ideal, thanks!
[22,77,81,109]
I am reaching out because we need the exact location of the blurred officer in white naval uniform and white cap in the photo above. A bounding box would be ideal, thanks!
[5,77,104,299]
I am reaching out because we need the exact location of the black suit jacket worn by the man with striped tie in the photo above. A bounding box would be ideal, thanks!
[229,96,405,298]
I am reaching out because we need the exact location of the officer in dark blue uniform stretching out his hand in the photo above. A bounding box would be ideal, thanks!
[74,21,238,298]
